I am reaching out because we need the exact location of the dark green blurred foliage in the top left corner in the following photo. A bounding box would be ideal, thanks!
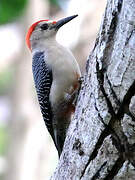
[0,0,27,24]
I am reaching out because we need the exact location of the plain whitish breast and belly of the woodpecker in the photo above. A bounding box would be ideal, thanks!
[47,42,81,104]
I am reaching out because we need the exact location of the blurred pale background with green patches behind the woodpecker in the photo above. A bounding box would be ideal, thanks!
[0,0,106,180]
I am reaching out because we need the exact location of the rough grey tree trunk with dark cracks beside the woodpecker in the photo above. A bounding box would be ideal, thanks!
[51,0,135,180]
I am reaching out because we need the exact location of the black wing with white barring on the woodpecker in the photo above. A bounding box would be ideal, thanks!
[32,52,55,143]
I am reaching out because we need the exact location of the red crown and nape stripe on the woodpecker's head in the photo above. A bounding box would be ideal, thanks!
[26,20,48,50]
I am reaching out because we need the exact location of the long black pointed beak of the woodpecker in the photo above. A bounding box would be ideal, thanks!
[52,15,78,30]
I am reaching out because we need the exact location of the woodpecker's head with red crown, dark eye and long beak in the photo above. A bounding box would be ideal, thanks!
[26,15,78,50]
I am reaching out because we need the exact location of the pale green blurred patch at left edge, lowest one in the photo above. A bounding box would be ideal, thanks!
[0,126,8,156]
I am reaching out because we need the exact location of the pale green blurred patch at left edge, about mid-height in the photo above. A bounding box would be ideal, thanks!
[0,67,14,95]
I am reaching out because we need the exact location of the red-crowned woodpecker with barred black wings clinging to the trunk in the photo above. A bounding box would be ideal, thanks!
[26,15,81,156]
